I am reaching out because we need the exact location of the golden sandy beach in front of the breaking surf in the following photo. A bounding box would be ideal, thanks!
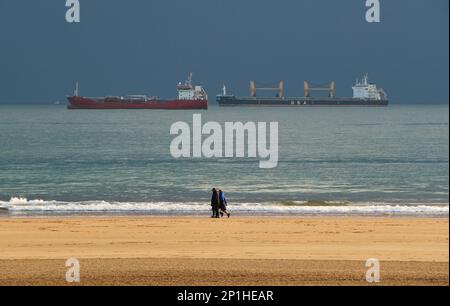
[0,216,449,285]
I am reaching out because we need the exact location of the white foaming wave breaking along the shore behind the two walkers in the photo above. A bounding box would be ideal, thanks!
[0,197,449,216]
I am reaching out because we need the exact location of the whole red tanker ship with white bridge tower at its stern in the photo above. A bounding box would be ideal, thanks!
[67,73,208,109]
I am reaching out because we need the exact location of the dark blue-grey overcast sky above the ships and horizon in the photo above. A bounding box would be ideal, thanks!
[0,0,449,103]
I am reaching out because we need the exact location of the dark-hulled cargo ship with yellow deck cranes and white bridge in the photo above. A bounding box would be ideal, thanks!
[216,74,389,106]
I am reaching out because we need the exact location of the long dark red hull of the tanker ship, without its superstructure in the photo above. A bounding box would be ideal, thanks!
[67,96,208,109]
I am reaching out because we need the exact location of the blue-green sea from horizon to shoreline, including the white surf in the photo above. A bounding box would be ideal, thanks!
[0,105,449,215]
